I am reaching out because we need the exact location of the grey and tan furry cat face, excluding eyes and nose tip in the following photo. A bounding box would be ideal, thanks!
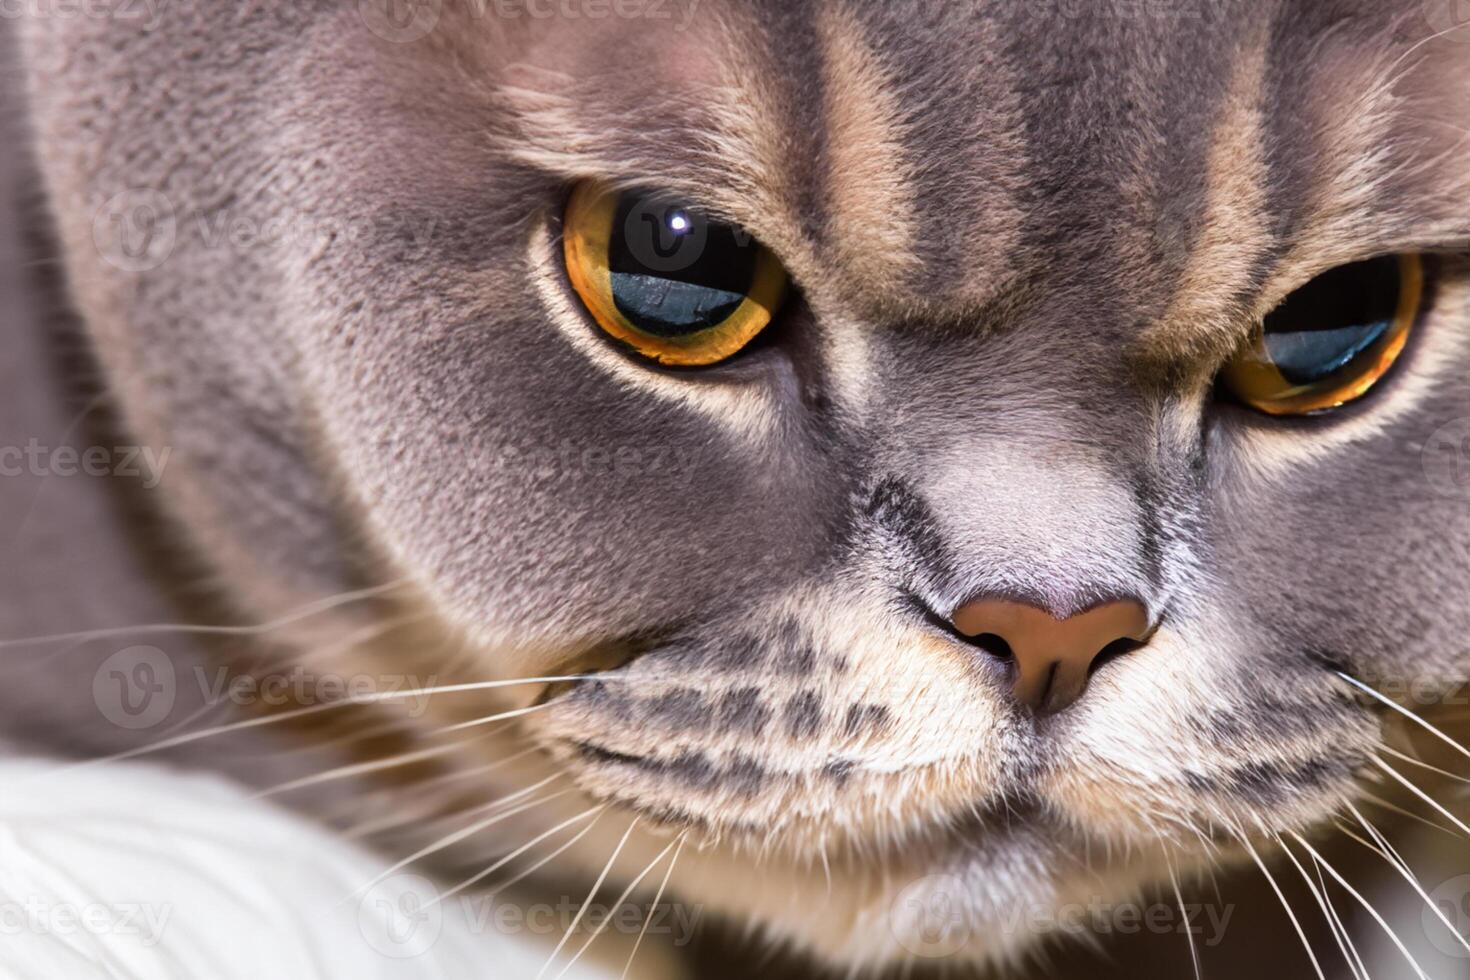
[26,0,1470,962]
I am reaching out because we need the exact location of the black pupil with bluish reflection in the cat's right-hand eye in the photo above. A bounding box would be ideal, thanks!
[1266,256,1401,385]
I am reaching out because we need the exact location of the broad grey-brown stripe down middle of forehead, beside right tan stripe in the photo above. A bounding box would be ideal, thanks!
[987,0,1236,314]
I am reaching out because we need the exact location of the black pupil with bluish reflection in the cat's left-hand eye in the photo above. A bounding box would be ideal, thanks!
[607,194,759,338]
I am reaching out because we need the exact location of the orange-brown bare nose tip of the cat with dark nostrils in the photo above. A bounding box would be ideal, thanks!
[951,595,1148,714]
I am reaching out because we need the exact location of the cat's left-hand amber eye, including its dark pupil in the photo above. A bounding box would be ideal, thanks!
[563,184,786,367]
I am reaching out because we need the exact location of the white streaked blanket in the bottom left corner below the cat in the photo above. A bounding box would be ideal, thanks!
[0,760,673,980]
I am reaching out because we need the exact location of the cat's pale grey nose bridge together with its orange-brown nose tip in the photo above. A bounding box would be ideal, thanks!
[864,345,1164,714]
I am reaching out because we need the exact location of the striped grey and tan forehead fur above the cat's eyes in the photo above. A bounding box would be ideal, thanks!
[416,0,1470,345]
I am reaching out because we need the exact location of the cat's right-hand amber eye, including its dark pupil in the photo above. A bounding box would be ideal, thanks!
[1222,254,1424,416]
